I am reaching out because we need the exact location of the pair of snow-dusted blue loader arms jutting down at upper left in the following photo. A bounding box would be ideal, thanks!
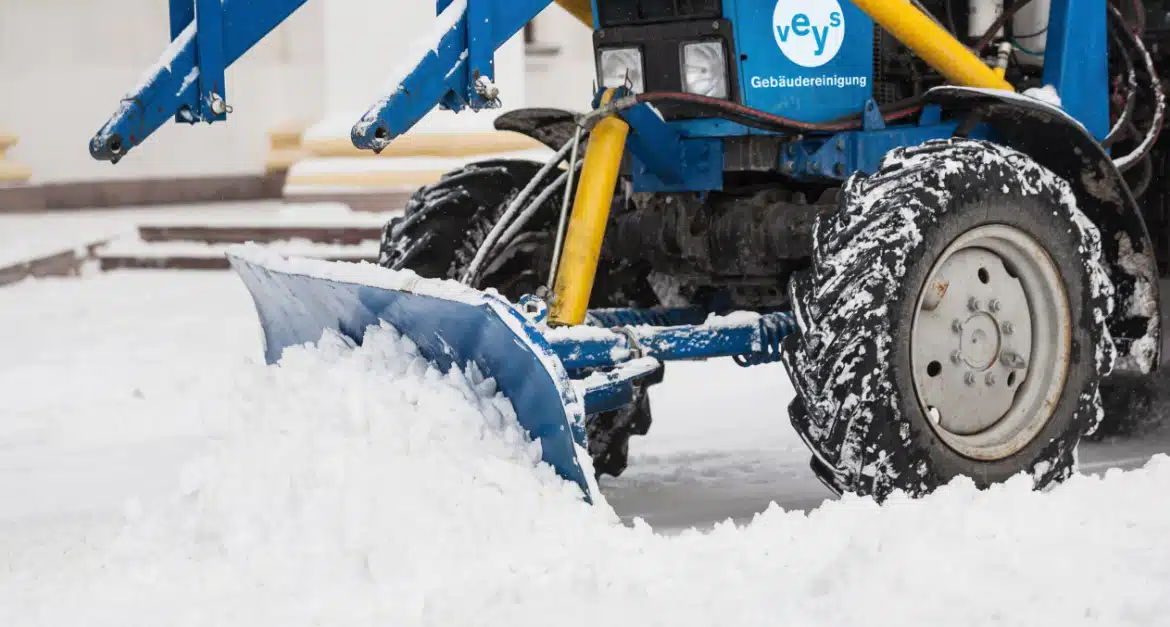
[89,0,552,163]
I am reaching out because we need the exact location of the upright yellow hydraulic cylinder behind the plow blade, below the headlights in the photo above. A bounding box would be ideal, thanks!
[549,102,629,325]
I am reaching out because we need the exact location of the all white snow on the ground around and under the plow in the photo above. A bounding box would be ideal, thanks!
[0,273,1170,627]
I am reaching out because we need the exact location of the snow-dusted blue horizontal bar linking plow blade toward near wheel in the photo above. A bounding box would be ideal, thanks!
[546,311,796,371]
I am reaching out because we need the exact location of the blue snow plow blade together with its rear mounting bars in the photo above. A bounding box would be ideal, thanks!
[229,247,792,499]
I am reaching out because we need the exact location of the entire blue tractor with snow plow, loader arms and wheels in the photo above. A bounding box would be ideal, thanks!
[90,0,1170,498]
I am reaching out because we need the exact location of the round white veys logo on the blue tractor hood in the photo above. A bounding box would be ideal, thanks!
[772,0,845,68]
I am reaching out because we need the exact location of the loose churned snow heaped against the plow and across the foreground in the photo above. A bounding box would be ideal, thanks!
[0,329,1170,627]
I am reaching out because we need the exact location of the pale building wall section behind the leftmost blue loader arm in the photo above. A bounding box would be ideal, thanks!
[0,0,323,181]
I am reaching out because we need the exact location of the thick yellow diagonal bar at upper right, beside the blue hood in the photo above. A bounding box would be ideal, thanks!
[853,0,1014,91]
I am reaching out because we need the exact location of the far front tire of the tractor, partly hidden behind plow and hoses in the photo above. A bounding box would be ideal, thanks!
[379,160,658,476]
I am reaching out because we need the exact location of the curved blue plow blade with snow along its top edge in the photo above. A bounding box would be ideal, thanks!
[228,246,590,499]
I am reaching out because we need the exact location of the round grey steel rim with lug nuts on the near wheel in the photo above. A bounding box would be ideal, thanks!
[910,225,1072,461]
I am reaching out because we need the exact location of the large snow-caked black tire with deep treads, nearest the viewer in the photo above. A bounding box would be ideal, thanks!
[783,138,1114,498]
